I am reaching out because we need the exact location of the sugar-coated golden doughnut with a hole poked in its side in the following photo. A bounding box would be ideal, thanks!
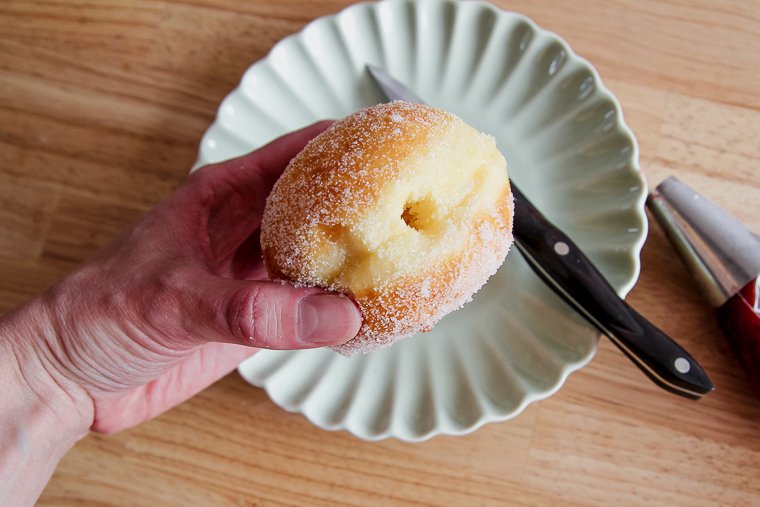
[261,102,513,355]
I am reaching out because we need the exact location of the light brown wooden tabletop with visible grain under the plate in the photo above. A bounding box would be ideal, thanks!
[0,0,760,506]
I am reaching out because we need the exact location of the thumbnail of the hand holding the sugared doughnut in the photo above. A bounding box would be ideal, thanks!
[298,294,361,345]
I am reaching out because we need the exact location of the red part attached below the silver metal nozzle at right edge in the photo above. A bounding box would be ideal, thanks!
[717,279,760,398]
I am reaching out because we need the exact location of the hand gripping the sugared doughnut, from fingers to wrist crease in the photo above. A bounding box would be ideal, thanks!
[5,122,361,433]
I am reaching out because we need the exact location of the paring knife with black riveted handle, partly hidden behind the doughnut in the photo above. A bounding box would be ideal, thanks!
[367,65,714,399]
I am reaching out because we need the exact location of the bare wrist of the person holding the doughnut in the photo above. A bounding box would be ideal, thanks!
[0,299,93,505]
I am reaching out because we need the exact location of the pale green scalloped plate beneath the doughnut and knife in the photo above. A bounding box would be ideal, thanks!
[198,0,647,441]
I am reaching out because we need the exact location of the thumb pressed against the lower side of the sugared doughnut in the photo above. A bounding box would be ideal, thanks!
[189,278,362,350]
